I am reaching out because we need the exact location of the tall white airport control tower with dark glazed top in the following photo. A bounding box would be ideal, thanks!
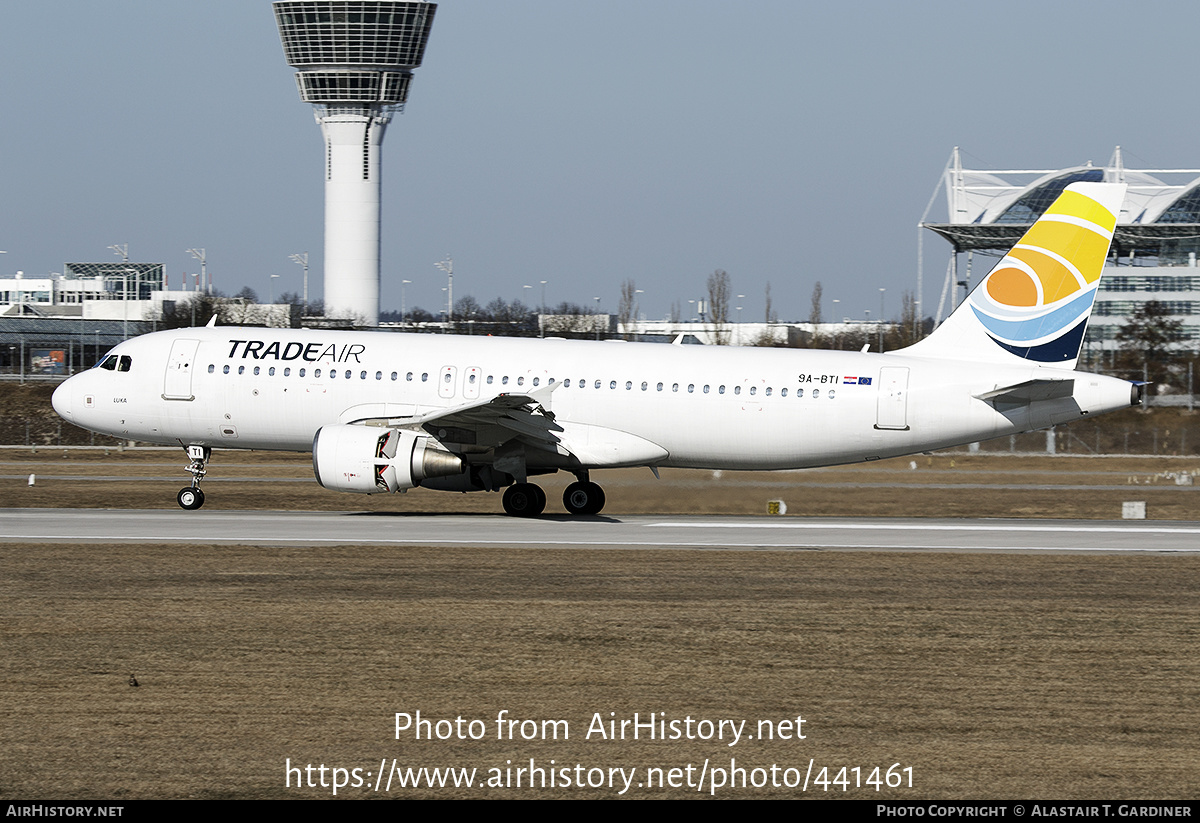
[274,0,437,325]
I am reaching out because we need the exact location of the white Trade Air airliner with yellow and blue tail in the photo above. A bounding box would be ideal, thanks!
[54,184,1142,516]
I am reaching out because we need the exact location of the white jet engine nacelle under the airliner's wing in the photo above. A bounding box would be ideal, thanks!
[312,426,464,494]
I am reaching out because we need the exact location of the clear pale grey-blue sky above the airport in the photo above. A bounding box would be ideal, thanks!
[0,0,1200,319]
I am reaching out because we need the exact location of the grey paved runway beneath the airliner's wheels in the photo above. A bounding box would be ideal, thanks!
[0,509,1200,553]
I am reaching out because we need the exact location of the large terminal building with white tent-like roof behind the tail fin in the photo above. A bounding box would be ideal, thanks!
[922,146,1200,356]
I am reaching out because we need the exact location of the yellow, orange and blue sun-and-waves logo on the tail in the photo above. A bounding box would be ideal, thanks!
[967,190,1116,362]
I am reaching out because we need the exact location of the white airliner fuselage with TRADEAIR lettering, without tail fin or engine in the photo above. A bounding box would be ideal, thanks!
[55,328,1132,469]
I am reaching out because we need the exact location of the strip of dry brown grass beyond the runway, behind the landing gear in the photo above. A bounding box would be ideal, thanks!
[9,449,1200,519]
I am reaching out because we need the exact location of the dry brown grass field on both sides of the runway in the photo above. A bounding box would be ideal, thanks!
[0,449,1200,800]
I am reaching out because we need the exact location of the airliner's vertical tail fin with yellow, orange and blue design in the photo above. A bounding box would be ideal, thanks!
[905,182,1126,368]
